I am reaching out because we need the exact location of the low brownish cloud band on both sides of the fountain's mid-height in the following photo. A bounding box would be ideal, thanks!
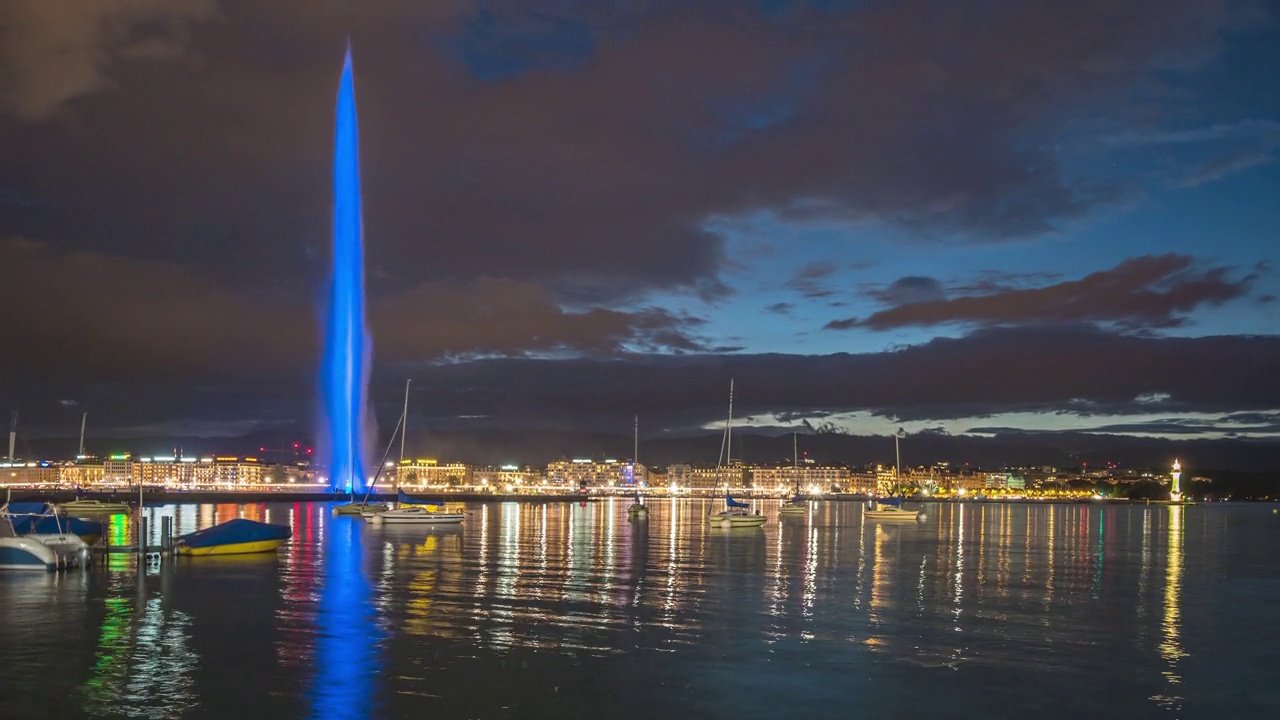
[0,234,704,382]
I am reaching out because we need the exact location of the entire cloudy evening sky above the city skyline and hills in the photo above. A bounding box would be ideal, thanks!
[0,0,1280,456]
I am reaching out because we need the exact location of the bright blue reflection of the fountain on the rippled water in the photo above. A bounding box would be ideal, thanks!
[310,516,381,720]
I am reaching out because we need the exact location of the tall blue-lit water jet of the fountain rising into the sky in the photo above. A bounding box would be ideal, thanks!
[320,46,371,492]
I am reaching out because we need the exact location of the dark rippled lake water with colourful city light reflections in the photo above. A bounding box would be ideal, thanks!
[0,500,1280,719]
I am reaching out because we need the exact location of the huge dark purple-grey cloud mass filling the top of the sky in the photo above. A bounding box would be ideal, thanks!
[0,0,1259,302]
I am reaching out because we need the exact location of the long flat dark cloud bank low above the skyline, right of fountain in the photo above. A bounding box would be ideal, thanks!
[368,327,1280,428]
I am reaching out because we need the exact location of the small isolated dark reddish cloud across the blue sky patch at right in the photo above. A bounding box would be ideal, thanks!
[826,254,1256,331]
